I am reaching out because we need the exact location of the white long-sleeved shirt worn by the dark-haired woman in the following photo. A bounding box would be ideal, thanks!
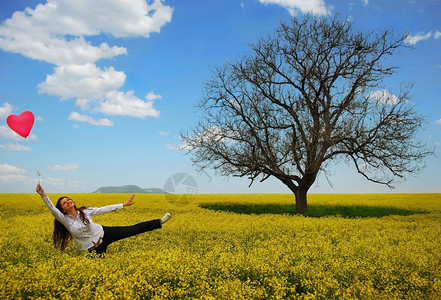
[43,196,124,250]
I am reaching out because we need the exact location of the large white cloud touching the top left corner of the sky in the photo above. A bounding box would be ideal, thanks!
[0,0,173,65]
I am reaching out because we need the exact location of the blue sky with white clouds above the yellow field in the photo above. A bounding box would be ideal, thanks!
[0,0,441,193]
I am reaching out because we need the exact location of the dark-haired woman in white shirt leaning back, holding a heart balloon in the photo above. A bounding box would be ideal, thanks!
[36,184,171,254]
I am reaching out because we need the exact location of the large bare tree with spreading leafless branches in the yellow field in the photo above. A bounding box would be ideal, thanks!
[181,15,431,213]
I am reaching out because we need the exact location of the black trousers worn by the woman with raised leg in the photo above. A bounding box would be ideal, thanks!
[89,219,162,254]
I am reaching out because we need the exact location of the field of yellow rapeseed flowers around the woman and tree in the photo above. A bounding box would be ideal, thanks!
[0,194,441,299]
